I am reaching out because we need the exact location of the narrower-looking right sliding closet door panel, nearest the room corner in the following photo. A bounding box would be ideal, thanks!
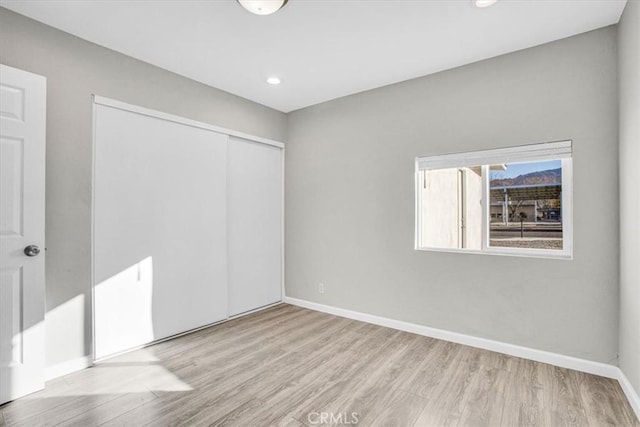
[227,137,282,316]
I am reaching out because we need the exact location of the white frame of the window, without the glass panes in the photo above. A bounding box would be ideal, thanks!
[415,140,573,259]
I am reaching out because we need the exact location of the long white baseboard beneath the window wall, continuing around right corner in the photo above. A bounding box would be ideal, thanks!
[284,297,640,419]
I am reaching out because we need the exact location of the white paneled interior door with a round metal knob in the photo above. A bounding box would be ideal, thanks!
[0,65,46,404]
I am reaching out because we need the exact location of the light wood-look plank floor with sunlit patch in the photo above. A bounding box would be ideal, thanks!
[0,304,640,427]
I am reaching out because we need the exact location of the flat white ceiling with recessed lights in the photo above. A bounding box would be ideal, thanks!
[0,0,626,112]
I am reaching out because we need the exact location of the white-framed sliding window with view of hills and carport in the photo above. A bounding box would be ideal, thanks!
[416,141,572,258]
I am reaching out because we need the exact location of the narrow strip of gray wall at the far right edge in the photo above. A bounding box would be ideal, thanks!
[618,0,640,394]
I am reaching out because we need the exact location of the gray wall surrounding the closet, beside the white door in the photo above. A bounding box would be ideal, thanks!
[0,8,287,366]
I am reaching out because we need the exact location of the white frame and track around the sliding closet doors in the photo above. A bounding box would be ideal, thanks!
[90,95,285,363]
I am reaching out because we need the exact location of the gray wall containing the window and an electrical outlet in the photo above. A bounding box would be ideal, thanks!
[286,27,619,363]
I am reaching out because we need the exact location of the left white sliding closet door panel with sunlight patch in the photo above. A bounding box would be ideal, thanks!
[94,104,228,358]
